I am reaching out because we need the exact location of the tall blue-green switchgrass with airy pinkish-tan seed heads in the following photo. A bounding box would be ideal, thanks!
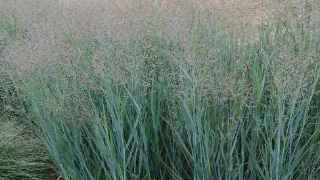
[3,1,320,179]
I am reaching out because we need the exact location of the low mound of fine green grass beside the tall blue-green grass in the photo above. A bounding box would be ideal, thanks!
[0,116,57,180]
